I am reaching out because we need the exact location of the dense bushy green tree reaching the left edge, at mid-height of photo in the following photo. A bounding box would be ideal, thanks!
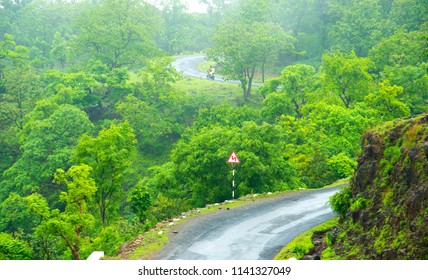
[1,105,93,202]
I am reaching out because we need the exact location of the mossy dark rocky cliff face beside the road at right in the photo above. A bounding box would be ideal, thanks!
[329,115,428,259]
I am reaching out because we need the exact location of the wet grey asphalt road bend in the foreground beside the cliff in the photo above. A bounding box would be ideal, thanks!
[153,187,338,260]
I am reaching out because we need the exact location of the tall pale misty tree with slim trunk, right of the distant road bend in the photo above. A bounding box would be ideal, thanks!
[208,20,293,101]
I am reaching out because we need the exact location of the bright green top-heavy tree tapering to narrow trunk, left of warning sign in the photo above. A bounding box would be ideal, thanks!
[72,123,135,225]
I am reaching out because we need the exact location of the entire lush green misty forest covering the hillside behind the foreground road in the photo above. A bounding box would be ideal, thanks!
[0,0,428,260]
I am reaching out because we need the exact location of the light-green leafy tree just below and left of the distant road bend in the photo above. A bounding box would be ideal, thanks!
[117,58,186,154]
